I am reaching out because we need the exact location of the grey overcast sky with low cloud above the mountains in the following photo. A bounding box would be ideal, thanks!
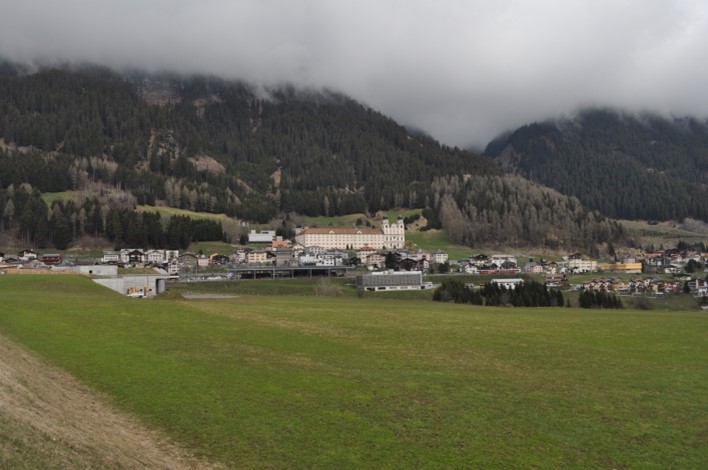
[0,0,708,147]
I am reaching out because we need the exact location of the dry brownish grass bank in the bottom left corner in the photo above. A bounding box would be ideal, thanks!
[0,335,219,469]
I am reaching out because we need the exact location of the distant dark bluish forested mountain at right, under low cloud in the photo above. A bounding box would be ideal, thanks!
[484,109,708,221]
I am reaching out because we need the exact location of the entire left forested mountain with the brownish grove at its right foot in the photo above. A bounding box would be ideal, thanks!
[0,63,623,252]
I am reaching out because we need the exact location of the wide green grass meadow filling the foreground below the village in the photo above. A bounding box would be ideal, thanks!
[0,275,708,469]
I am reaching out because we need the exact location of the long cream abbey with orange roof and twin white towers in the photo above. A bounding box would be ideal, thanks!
[295,217,406,250]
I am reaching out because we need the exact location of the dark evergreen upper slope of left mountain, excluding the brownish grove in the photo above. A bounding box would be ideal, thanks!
[0,63,497,222]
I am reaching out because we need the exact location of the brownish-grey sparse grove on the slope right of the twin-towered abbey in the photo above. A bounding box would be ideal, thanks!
[423,176,628,256]
